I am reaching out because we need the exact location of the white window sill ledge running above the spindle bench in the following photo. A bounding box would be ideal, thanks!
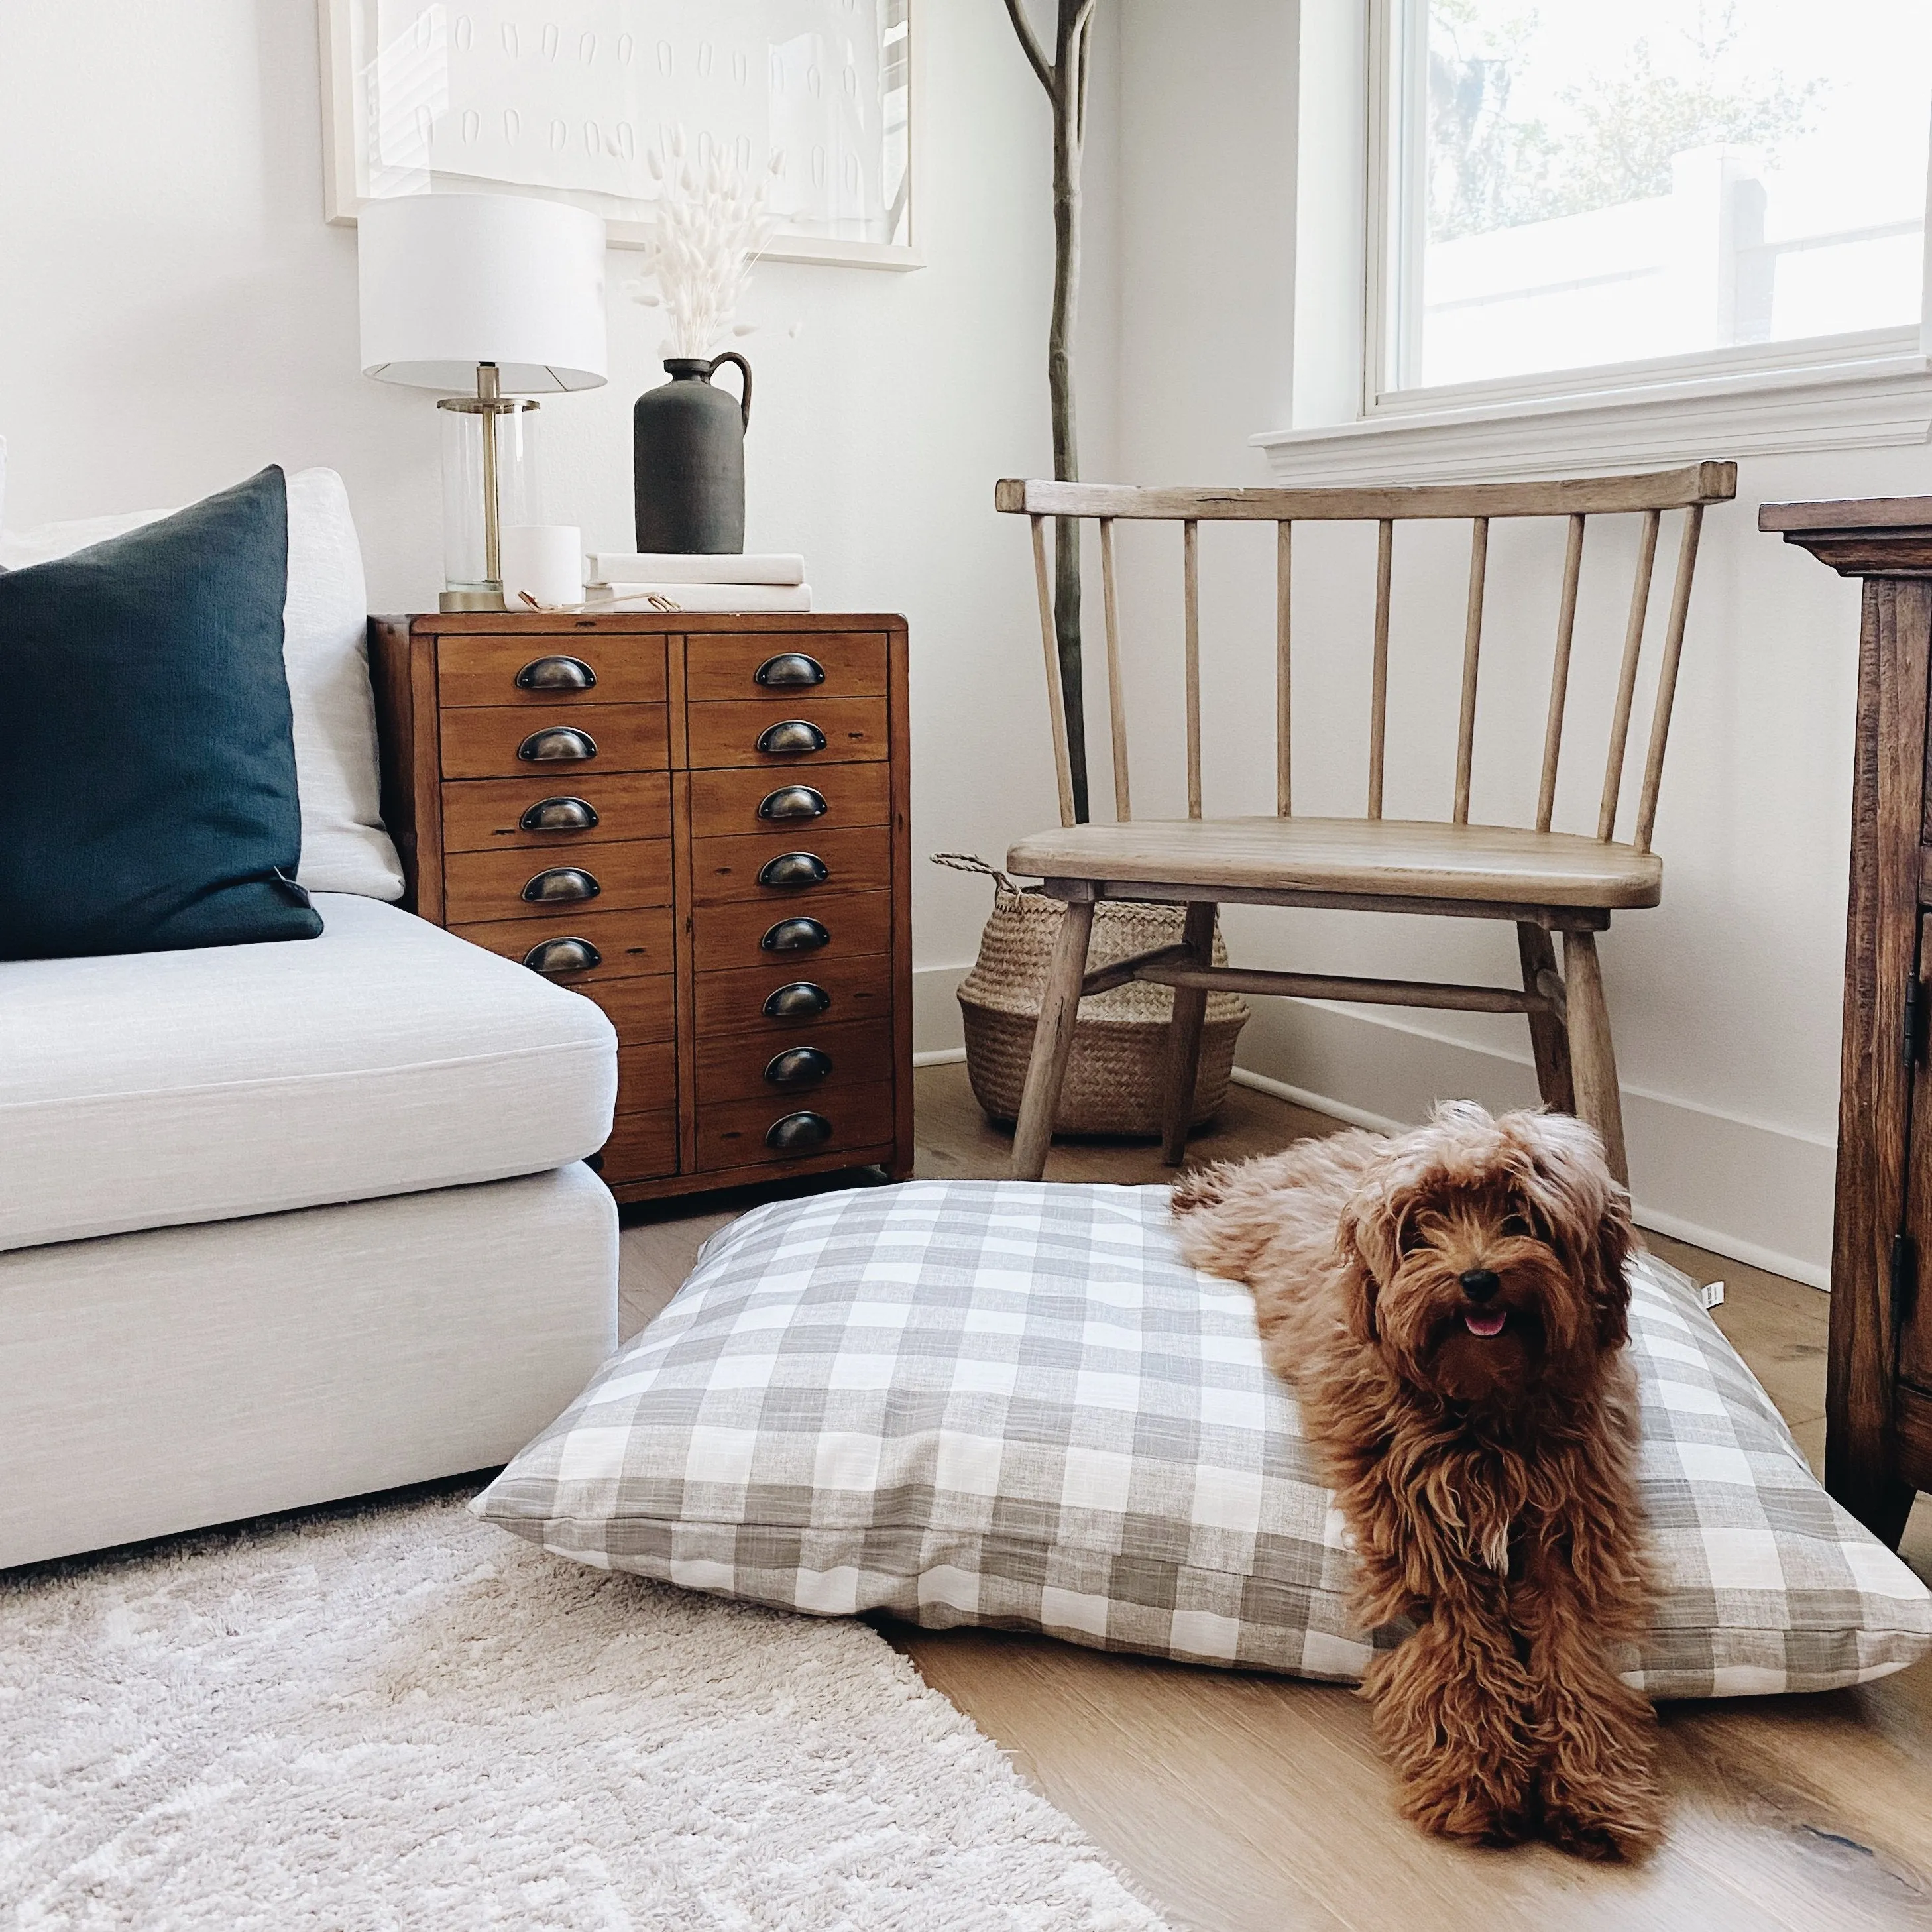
[1250,353,1932,487]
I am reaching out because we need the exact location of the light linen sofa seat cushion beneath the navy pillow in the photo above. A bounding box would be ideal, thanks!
[0,893,616,1248]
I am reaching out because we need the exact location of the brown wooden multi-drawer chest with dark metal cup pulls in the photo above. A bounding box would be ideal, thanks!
[369,612,912,1202]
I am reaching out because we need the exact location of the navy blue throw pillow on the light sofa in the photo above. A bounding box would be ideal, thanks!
[0,467,323,958]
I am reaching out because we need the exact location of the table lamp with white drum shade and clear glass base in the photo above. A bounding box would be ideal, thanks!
[355,195,604,610]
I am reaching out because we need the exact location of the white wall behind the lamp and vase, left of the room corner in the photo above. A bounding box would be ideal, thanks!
[0,0,1113,1043]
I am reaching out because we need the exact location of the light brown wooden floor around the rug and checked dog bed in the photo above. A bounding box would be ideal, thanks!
[622,1066,1932,1932]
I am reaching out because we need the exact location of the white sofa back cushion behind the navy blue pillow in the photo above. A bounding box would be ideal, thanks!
[0,469,402,898]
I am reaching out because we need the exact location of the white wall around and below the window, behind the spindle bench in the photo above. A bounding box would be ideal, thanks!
[1082,0,1932,1284]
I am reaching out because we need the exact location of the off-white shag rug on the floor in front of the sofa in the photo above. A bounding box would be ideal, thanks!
[0,1493,1161,1932]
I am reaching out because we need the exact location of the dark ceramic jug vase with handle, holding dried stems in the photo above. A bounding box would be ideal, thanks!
[630,350,752,557]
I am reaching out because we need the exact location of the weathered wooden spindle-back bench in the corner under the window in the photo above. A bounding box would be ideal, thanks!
[995,462,1737,1178]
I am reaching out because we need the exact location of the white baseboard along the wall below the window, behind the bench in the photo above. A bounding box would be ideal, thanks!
[1235,999,1837,1288]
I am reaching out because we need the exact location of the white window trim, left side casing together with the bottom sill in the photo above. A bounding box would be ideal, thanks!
[1250,0,1932,485]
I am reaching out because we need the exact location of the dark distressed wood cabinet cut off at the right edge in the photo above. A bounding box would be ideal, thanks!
[1758,496,1932,1546]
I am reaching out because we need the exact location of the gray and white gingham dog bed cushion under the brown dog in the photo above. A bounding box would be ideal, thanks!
[471,1180,1932,1696]
